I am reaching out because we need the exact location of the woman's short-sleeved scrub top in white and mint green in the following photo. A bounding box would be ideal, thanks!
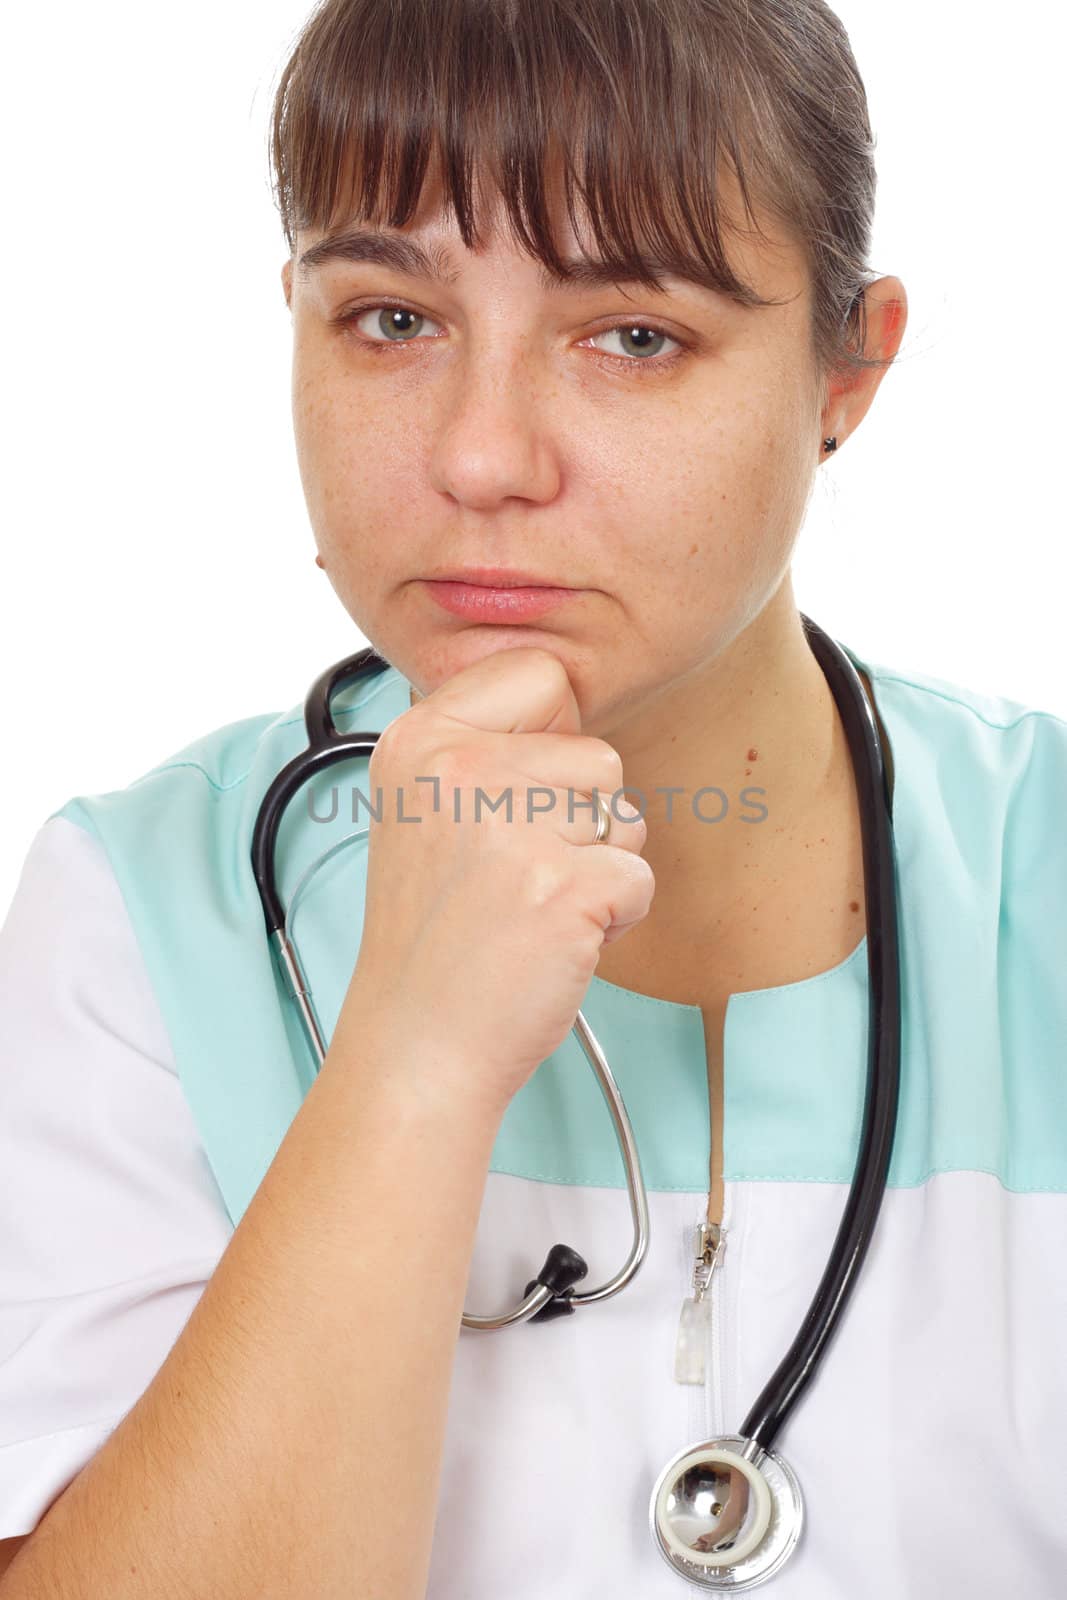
[0,630,1067,1600]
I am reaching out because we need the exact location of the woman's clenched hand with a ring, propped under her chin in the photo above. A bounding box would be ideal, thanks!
[338,646,656,1115]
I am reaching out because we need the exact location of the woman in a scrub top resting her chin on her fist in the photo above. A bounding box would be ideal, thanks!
[0,0,1067,1600]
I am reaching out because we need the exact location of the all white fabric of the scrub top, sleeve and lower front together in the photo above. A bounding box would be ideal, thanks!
[0,818,1067,1600]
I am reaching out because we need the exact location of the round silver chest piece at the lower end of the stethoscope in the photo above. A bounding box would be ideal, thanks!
[648,1434,805,1589]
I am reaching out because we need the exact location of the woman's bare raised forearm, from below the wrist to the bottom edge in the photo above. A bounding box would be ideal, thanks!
[0,1038,496,1600]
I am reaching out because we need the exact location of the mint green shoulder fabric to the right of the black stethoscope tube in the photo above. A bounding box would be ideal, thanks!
[859,646,1067,1194]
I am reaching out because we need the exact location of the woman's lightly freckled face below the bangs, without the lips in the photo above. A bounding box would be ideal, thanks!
[283,159,902,733]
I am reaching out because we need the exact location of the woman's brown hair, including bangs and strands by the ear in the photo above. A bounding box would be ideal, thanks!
[270,0,888,396]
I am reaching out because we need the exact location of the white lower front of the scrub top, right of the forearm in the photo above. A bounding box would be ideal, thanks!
[454,1173,1067,1600]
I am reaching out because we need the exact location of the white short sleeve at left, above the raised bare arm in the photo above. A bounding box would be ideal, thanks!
[0,816,234,1539]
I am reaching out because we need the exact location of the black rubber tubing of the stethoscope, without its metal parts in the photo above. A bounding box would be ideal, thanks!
[251,613,901,1451]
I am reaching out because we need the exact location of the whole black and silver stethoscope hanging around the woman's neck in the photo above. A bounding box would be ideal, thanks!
[251,613,901,1589]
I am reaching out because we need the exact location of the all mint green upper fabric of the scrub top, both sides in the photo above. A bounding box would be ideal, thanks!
[53,646,1067,1224]
